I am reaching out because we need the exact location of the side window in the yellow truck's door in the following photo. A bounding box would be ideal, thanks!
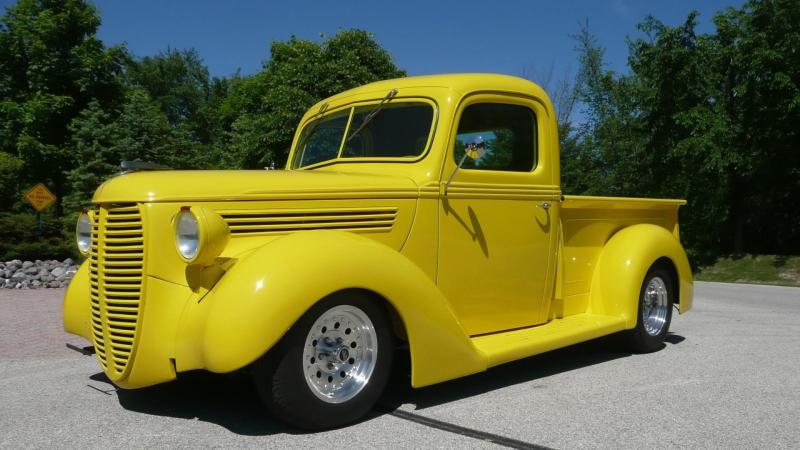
[453,103,537,172]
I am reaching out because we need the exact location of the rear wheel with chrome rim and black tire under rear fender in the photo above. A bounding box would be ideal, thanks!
[627,265,676,353]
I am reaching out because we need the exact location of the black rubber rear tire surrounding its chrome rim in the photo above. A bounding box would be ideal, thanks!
[625,265,676,353]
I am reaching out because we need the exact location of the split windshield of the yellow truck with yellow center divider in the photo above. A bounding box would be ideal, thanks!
[292,102,433,169]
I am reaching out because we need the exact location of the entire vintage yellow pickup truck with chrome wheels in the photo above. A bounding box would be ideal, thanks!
[64,74,692,429]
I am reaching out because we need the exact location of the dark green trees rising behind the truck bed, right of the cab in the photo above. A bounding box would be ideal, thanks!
[564,0,800,259]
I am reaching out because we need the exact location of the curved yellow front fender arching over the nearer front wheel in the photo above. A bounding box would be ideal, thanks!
[179,230,487,386]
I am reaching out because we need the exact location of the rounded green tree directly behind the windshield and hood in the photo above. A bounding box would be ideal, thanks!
[221,30,405,168]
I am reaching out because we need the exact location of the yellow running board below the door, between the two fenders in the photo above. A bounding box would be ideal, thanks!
[472,314,625,367]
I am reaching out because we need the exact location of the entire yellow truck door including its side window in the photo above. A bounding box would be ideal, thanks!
[437,95,560,335]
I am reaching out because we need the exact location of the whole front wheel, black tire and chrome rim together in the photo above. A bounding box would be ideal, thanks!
[254,293,394,430]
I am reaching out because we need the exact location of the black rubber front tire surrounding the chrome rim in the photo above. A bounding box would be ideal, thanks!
[253,292,394,430]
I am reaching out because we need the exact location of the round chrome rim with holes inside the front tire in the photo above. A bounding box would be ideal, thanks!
[303,305,378,403]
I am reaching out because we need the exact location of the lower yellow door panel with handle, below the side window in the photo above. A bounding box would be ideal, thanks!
[437,193,552,335]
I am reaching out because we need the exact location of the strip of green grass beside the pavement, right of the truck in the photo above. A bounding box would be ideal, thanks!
[694,255,800,286]
